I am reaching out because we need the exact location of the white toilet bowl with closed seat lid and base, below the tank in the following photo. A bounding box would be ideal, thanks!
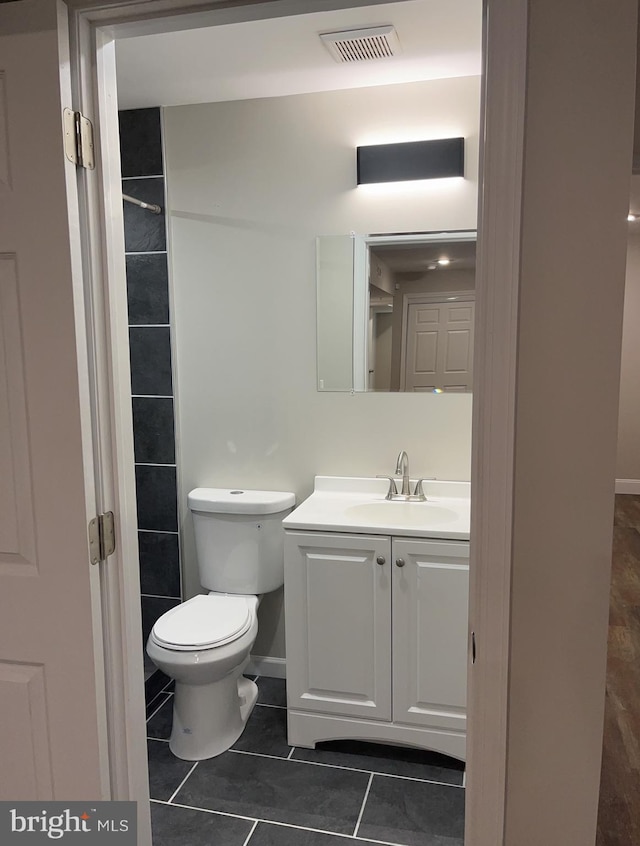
[147,593,259,761]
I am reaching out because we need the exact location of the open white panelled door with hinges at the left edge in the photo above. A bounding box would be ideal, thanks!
[0,0,108,800]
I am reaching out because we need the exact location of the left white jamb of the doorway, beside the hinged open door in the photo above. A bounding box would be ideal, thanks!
[64,6,151,846]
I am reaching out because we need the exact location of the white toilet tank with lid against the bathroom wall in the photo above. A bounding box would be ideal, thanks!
[188,488,295,594]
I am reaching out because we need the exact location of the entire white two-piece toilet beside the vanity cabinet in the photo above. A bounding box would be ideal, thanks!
[147,488,295,761]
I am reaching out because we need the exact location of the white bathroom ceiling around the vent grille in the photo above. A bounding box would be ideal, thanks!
[116,0,482,109]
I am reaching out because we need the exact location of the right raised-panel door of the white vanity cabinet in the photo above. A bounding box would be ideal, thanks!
[392,539,469,731]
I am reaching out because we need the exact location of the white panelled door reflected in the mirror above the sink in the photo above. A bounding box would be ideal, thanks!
[405,301,475,392]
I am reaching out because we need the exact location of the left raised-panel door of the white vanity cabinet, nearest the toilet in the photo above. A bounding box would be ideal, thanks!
[285,532,391,720]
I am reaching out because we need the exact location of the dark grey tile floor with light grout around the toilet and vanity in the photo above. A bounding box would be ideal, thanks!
[147,677,464,846]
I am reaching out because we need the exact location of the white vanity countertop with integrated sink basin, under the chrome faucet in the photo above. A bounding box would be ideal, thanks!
[282,476,470,540]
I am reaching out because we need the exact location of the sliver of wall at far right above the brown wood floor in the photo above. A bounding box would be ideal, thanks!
[616,232,640,480]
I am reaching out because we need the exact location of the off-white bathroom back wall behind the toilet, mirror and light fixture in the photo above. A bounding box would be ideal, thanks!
[164,77,480,656]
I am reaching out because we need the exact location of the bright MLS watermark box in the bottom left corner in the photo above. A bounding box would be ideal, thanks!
[0,802,137,846]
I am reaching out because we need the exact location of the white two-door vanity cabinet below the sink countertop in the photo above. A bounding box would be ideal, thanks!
[285,531,469,759]
